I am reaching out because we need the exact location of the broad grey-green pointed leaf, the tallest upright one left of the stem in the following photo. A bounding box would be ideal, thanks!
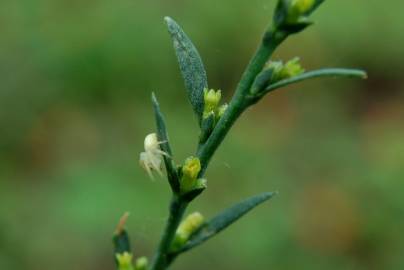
[165,17,208,122]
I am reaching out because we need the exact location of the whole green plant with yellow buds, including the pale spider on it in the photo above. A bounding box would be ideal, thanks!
[113,0,366,270]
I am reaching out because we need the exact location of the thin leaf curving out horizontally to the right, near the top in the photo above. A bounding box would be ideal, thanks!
[262,68,367,95]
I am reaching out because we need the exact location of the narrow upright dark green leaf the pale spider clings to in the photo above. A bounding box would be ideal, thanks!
[152,93,180,192]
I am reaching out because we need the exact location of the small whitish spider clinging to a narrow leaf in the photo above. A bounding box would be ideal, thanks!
[139,133,168,179]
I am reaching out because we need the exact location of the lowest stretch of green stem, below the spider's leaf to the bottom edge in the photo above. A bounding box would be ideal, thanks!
[150,195,188,270]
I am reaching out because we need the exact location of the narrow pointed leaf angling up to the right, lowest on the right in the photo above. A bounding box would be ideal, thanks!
[178,192,276,253]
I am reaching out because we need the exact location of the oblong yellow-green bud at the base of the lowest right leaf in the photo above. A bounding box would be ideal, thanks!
[172,212,205,250]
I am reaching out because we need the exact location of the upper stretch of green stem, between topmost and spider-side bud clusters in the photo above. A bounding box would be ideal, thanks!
[197,28,287,177]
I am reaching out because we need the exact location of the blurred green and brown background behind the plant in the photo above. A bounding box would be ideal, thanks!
[0,0,404,270]
